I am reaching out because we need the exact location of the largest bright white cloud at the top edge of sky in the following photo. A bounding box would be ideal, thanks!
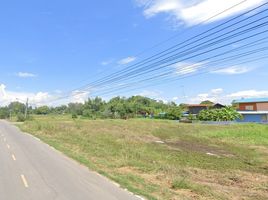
[136,0,265,25]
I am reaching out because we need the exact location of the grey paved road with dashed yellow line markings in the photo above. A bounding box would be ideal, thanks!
[0,121,140,200]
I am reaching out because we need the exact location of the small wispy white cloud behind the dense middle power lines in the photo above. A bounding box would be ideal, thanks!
[173,63,204,75]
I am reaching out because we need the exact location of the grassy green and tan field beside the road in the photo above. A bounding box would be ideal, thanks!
[19,116,268,200]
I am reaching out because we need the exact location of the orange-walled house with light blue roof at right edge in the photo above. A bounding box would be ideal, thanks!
[233,98,268,123]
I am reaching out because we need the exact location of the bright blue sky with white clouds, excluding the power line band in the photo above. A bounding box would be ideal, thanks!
[0,0,268,106]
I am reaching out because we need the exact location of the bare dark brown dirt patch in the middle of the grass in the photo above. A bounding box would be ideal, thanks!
[166,140,234,157]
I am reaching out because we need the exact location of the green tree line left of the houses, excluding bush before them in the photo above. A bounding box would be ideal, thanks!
[0,96,183,121]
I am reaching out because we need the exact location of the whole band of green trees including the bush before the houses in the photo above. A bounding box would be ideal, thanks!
[0,96,241,121]
